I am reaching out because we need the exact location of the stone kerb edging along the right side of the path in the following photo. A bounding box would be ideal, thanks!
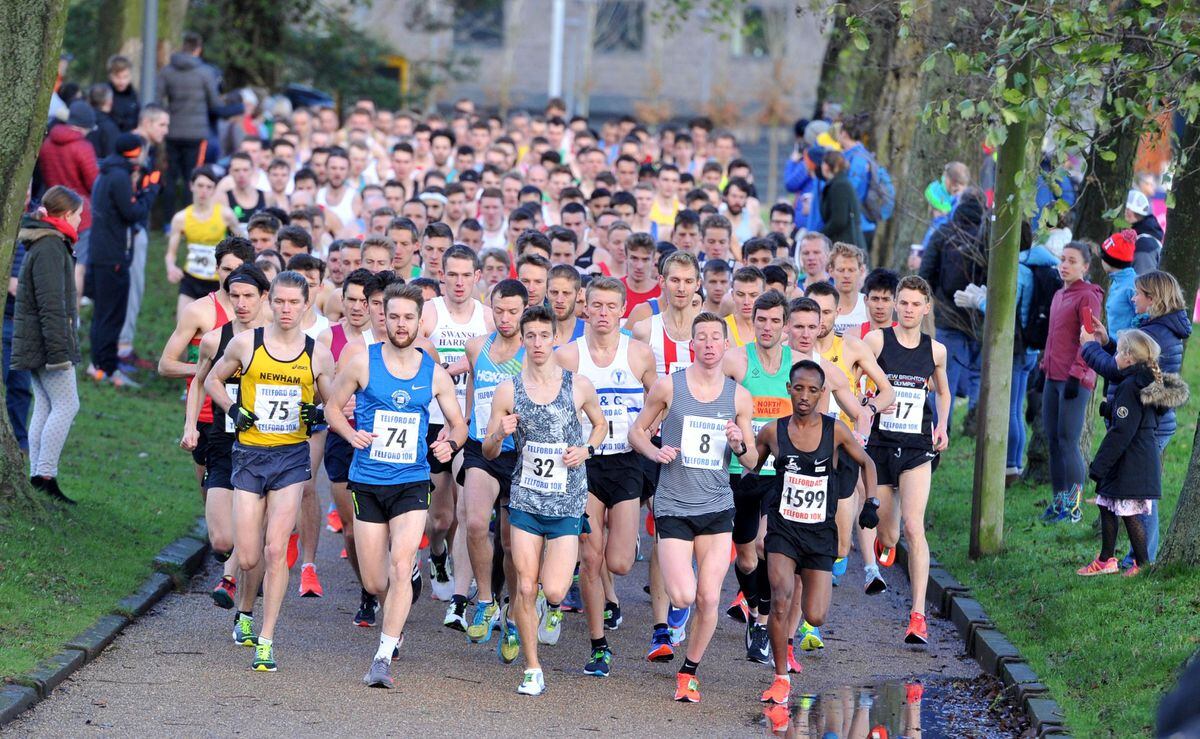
[895,541,1070,737]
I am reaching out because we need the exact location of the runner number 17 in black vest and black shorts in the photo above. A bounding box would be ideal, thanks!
[863,275,952,644]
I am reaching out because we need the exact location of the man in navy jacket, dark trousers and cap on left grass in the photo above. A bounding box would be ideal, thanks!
[85,133,158,389]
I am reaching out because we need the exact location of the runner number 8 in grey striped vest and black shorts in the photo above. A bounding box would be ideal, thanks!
[629,313,758,703]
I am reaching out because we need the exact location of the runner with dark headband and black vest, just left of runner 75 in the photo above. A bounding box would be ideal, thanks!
[180,264,270,647]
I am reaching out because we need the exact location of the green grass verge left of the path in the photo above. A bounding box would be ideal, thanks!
[0,238,203,678]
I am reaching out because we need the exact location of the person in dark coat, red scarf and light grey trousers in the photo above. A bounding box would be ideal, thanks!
[12,187,90,504]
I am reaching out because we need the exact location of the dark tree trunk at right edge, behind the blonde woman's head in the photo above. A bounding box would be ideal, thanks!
[1163,116,1200,304]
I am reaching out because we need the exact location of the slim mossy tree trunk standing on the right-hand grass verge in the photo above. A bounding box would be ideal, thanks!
[970,55,1030,559]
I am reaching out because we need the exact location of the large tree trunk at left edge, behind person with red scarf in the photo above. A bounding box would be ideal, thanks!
[0,0,67,519]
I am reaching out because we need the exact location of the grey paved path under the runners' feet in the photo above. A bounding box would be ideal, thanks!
[4,496,993,739]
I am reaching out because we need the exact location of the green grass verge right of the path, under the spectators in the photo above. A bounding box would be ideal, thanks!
[926,338,1200,737]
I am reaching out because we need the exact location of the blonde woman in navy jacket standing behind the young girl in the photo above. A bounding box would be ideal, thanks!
[1084,271,1192,566]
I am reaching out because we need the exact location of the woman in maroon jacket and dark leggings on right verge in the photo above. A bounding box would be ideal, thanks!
[1042,241,1103,523]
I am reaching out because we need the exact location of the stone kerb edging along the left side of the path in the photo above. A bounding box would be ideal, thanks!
[0,517,209,726]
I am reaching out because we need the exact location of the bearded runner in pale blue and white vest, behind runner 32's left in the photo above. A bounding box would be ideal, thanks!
[456,280,529,662]
